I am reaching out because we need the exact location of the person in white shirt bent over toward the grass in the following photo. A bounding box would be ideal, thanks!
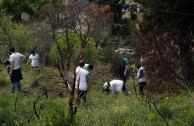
[102,79,124,92]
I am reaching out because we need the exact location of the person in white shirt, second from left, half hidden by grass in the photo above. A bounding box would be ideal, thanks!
[26,50,40,68]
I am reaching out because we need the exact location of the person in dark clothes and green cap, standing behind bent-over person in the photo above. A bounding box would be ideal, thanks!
[119,58,129,91]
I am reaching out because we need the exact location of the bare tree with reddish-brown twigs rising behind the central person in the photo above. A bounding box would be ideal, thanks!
[71,4,112,59]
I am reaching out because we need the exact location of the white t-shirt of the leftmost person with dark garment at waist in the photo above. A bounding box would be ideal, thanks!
[9,53,24,70]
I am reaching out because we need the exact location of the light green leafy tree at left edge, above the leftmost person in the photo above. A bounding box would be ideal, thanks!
[0,16,31,55]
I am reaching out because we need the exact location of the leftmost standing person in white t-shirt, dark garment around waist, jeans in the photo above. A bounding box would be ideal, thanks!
[9,47,25,93]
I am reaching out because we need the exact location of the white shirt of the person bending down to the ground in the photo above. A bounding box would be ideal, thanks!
[103,80,123,92]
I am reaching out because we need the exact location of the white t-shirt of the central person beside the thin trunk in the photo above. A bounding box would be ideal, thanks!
[75,67,89,91]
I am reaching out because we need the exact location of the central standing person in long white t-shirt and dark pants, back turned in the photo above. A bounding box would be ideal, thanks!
[75,60,89,105]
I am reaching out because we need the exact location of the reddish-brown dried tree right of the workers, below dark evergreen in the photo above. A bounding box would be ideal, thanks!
[133,25,191,92]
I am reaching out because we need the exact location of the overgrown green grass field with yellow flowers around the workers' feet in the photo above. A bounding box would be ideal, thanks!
[0,67,194,126]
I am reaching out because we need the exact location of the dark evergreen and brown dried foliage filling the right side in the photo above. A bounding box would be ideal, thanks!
[133,0,194,91]
